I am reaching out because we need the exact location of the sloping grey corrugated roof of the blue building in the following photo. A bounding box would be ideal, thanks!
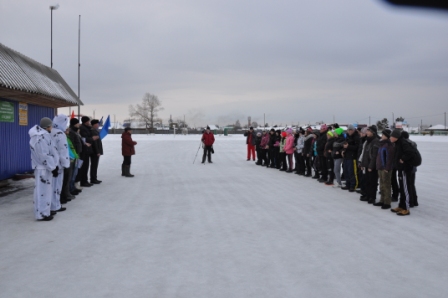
[0,43,83,106]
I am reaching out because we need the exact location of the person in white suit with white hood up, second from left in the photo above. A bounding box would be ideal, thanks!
[51,114,70,214]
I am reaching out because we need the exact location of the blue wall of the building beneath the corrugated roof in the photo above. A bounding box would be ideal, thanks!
[0,98,54,180]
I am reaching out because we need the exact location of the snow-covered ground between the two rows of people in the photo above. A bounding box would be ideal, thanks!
[0,135,448,298]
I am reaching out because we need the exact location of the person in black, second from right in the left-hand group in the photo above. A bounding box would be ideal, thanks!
[77,116,99,187]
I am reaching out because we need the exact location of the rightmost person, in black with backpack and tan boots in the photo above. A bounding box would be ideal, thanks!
[390,129,422,216]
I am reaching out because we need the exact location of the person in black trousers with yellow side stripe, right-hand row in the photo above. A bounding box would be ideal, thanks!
[341,124,360,192]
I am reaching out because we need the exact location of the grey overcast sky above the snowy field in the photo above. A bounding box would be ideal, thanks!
[0,0,448,125]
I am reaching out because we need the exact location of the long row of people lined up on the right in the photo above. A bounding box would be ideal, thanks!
[244,124,422,216]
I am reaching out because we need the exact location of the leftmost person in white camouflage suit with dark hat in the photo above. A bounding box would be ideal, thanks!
[28,118,58,221]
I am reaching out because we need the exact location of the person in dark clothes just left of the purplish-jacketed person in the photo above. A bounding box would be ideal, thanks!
[360,126,380,206]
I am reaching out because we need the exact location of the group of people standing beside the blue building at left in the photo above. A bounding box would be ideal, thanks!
[29,114,103,221]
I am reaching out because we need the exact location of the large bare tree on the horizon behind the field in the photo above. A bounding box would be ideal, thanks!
[129,93,163,132]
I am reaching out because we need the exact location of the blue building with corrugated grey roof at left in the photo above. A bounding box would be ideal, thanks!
[0,43,82,180]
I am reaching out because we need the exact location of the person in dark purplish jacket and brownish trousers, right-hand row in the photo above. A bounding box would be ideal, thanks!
[374,128,395,209]
